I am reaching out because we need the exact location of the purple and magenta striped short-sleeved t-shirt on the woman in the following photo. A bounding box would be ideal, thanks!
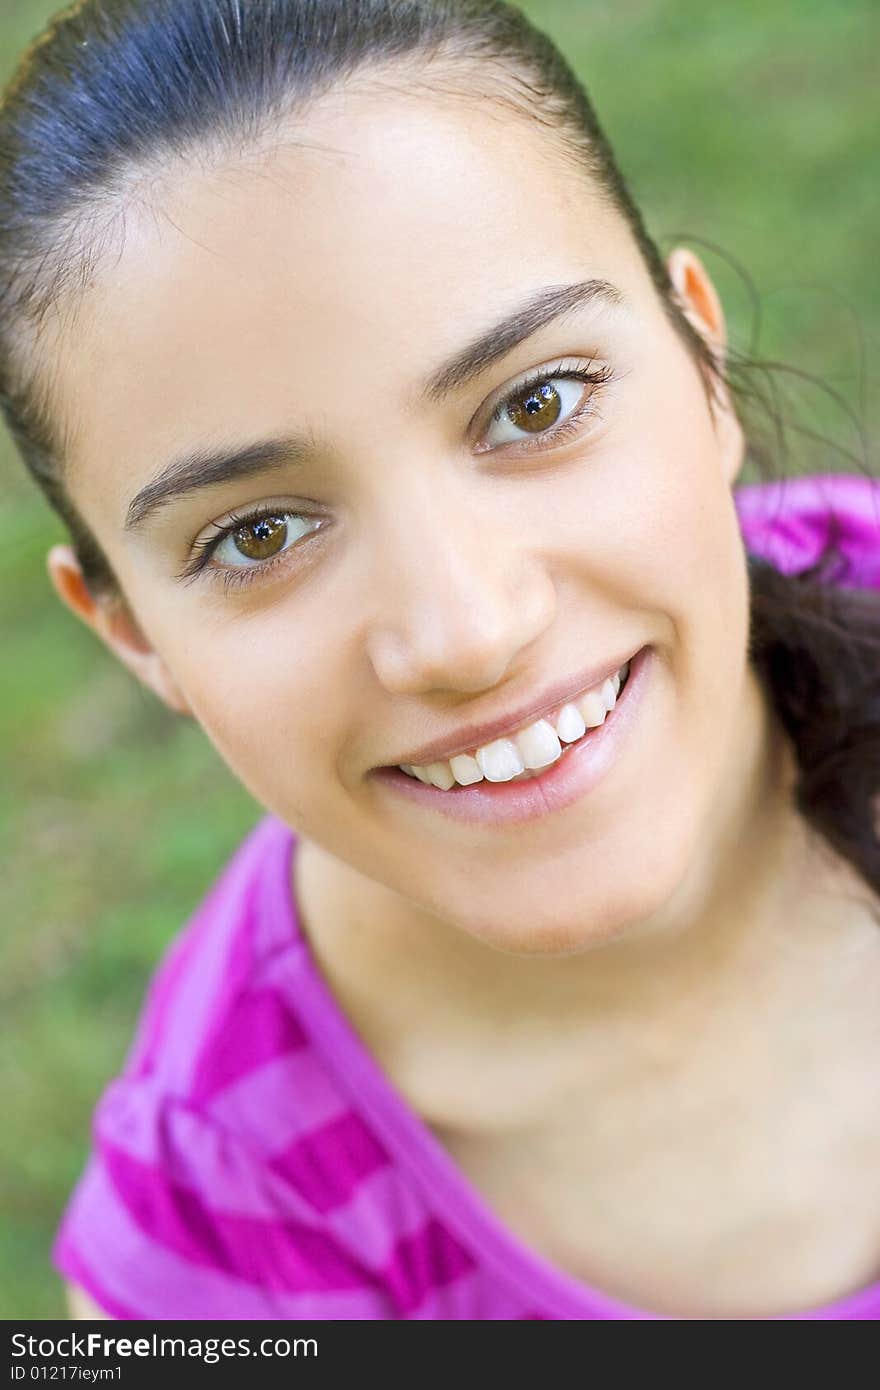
[53,475,880,1321]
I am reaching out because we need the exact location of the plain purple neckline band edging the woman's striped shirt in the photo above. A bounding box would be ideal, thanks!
[266,816,880,1322]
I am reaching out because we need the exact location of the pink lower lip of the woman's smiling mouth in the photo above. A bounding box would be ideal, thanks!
[370,646,653,826]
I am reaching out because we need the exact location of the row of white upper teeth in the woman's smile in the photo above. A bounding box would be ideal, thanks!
[400,662,630,791]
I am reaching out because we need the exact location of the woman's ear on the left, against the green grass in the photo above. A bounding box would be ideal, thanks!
[46,545,192,716]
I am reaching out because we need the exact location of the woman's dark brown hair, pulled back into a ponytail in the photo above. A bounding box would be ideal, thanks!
[0,0,880,920]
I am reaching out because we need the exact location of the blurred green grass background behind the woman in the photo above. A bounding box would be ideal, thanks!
[0,0,880,1318]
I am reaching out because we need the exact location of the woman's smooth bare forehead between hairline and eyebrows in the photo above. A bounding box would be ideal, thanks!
[57,92,635,491]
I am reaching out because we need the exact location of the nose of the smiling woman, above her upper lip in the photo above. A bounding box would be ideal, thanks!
[358,498,556,695]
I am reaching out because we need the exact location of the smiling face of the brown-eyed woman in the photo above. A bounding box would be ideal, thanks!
[50,90,755,952]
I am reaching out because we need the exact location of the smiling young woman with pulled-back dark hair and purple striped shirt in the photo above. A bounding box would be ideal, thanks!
[0,0,880,1319]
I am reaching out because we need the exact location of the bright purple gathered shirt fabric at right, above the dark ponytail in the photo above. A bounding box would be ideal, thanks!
[734,473,880,589]
